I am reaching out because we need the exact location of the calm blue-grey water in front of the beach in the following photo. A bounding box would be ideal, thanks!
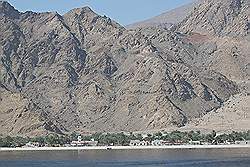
[0,149,250,167]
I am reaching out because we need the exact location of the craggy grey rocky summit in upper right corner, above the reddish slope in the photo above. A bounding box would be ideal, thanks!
[180,0,250,37]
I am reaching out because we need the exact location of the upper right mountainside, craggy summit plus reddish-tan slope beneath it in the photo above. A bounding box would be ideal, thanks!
[178,0,250,82]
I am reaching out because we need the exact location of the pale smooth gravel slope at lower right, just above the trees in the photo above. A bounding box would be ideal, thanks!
[182,94,250,132]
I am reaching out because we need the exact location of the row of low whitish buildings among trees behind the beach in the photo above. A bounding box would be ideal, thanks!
[19,133,250,148]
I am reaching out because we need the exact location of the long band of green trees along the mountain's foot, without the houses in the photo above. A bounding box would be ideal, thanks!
[0,131,250,147]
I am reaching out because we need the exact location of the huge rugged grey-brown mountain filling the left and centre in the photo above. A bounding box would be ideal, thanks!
[0,1,247,135]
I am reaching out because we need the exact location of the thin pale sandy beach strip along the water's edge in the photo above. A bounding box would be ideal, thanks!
[0,145,250,152]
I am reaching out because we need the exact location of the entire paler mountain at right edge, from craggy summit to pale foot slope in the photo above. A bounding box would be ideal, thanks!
[176,0,250,131]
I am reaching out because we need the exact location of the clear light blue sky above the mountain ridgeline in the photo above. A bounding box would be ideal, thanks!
[7,0,192,25]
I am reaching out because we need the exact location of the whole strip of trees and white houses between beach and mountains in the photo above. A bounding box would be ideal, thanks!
[0,131,250,148]
